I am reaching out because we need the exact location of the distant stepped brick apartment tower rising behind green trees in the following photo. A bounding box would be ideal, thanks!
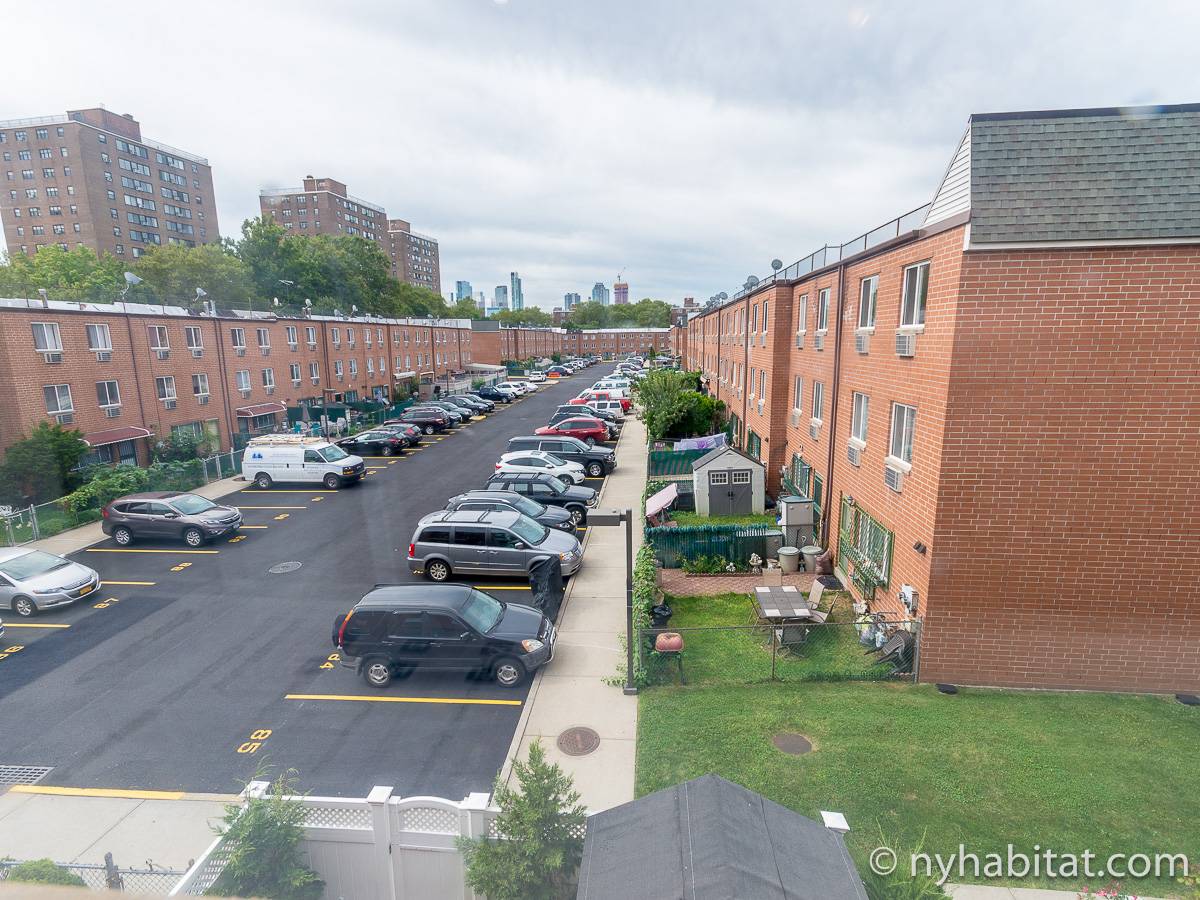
[258,181,442,294]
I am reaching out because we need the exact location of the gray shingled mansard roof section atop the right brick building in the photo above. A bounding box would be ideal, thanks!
[926,104,1200,246]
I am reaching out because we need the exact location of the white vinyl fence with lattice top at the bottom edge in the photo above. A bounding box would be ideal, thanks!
[170,781,497,900]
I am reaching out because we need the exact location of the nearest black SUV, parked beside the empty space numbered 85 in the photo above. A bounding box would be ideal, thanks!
[334,584,557,688]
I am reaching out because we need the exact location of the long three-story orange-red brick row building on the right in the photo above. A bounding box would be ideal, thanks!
[673,106,1200,691]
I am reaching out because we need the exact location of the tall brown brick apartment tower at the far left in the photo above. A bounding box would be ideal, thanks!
[0,108,221,257]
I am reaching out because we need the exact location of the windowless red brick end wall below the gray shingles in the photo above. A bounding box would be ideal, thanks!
[922,247,1200,691]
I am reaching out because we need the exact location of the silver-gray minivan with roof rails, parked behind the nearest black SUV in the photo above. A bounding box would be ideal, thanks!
[408,510,583,581]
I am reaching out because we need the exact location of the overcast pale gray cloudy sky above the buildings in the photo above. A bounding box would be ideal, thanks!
[9,0,1200,308]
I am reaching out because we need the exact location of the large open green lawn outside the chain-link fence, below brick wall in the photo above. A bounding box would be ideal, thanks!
[637,686,1200,896]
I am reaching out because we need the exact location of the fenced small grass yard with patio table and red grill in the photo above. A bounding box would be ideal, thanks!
[647,594,889,684]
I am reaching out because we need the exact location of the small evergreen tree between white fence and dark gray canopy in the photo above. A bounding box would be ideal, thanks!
[456,740,587,900]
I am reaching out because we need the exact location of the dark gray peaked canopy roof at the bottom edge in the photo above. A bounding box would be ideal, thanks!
[576,775,866,900]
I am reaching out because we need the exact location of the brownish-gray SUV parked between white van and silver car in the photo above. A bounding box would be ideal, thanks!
[100,491,241,547]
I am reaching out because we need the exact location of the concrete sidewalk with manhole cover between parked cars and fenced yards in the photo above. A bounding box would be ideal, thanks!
[500,418,646,812]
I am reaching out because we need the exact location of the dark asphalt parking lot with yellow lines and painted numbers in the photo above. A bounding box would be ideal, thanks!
[0,370,602,798]
